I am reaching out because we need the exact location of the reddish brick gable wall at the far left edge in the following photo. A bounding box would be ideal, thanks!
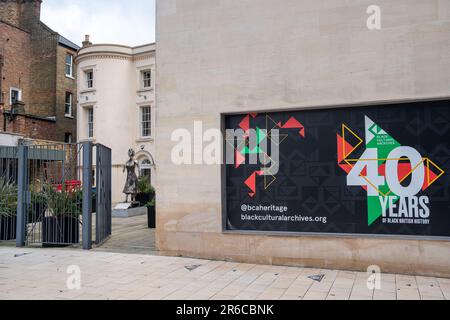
[0,22,31,110]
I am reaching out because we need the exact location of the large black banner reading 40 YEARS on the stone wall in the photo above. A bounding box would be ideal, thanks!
[224,101,450,237]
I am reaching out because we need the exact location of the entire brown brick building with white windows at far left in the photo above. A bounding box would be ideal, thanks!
[0,0,79,142]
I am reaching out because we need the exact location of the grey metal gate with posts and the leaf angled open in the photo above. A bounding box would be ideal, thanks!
[7,142,111,249]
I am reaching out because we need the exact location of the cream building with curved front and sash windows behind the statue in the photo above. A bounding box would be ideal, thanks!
[76,39,155,203]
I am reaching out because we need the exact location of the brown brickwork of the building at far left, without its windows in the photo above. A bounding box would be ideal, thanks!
[0,0,77,141]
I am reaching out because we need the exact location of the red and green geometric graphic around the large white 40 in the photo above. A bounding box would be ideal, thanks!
[337,116,445,226]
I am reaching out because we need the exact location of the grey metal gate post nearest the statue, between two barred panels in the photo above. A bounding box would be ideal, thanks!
[82,142,92,250]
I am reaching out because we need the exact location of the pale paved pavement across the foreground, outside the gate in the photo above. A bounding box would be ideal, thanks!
[0,247,450,300]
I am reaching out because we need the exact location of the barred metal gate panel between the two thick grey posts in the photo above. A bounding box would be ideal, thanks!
[18,144,83,246]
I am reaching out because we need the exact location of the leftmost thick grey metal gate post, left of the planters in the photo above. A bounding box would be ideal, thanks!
[16,145,28,248]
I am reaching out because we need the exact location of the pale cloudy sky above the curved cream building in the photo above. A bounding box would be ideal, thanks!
[41,0,155,46]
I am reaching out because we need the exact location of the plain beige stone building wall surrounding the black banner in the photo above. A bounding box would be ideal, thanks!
[156,0,450,276]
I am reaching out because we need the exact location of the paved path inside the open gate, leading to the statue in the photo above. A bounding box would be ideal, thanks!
[94,215,156,255]
